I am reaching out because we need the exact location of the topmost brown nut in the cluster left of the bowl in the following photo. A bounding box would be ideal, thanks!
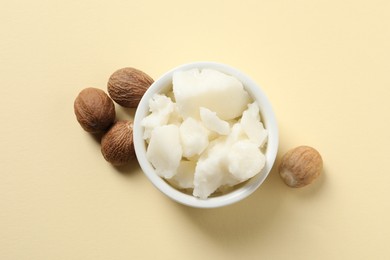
[107,67,153,108]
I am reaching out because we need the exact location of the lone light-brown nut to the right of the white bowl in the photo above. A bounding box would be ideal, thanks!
[279,146,323,188]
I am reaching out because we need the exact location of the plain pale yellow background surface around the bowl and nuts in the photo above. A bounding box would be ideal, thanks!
[0,0,390,260]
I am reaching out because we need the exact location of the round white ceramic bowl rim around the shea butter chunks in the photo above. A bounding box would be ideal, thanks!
[133,62,279,208]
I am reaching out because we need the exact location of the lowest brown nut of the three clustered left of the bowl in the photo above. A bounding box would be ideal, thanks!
[101,120,135,166]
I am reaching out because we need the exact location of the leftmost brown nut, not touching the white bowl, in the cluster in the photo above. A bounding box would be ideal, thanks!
[73,88,115,133]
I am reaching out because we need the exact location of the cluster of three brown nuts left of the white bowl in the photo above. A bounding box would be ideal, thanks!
[74,67,153,166]
